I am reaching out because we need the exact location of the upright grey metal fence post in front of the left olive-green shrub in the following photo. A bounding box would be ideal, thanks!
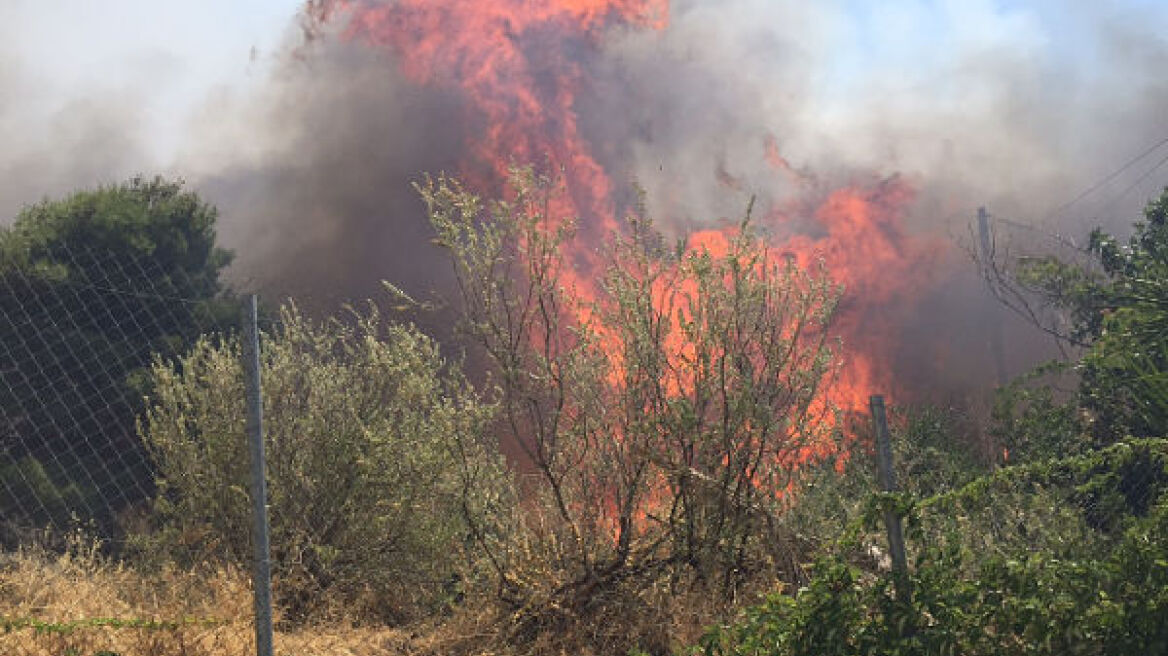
[243,294,272,656]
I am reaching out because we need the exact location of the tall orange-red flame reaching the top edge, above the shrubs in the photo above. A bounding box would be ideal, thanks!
[324,0,668,227]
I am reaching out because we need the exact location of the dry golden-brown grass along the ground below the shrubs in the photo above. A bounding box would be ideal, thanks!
[0,536,775,656]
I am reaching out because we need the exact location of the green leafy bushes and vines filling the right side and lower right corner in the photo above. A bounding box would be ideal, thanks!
[697,190,1168,656]
